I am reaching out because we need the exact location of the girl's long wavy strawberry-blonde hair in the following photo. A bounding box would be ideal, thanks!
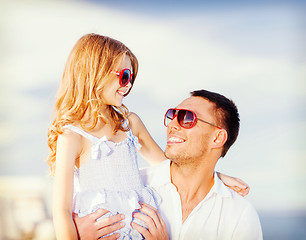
[47,34,138,174]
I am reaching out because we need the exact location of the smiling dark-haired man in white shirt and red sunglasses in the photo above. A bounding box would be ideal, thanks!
[73,90,262,240]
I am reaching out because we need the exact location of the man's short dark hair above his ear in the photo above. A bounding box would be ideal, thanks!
[190,90,240,157]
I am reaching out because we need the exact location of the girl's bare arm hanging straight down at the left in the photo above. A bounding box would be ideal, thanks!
[53,129,81,240]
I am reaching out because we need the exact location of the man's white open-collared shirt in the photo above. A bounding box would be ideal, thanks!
[141,160,262,240]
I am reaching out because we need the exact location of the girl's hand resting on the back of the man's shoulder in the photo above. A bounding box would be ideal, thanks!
[217,172,250,197]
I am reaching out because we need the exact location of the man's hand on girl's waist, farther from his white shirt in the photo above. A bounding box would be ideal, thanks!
[72,209,125,240]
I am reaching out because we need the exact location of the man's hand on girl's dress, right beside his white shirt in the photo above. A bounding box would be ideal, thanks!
[131,203,169,240]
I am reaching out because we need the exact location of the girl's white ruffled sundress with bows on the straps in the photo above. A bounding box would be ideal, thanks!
[64,121,160,239]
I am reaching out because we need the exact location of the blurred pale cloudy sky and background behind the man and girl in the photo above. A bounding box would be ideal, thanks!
[0,0,306,239]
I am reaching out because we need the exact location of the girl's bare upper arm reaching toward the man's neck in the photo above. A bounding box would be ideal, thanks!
[128,113,166,164]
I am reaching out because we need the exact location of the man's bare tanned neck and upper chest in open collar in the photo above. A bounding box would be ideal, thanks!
[170,162,214,222]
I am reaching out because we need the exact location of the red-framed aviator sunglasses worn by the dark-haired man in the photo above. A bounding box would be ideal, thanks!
[164,108,222,129]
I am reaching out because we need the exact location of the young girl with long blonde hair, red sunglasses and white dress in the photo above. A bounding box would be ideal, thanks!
[48,34,249,240]
